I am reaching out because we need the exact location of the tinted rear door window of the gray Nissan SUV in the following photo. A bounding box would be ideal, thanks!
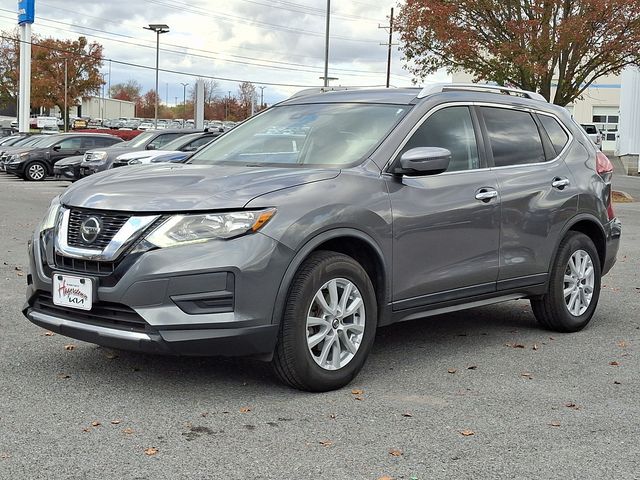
[481,107,545,167]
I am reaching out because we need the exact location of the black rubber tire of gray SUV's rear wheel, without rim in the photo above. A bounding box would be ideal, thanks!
[531,231,601,332]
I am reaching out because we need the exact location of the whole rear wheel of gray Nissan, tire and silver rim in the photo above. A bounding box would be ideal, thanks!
[531,231,601,332]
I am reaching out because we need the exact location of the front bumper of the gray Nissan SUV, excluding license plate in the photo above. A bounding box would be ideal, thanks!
[23,233,293,359]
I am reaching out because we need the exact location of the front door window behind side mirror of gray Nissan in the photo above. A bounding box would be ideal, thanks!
[401,107,480,172]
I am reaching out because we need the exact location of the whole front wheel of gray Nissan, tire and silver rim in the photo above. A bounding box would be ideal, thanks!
[273,251,378,392]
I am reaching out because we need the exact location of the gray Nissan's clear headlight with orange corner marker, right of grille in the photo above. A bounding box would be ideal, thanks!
[146,208,276,247]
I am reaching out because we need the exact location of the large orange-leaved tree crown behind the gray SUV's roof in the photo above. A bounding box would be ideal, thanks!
[397,0,640,105]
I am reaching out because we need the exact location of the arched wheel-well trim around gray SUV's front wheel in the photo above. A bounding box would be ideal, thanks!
[271,228,391,326]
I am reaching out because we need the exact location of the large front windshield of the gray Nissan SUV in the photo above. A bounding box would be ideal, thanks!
[189,103,409,166]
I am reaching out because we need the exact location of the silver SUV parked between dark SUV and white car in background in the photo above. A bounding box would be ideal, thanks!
[80,129,196,177]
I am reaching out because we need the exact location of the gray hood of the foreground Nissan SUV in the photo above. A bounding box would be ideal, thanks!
[60,164,340,212]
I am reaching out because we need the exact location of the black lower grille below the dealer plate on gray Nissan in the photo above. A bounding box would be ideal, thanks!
[33,291,147,332]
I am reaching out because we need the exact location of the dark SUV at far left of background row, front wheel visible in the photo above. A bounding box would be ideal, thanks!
[5,133,122,181]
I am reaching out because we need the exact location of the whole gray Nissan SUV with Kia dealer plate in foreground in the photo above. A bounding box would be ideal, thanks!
[24,84,621,391]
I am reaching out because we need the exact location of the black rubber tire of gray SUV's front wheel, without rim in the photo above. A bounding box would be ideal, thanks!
[272,251,378,392]
